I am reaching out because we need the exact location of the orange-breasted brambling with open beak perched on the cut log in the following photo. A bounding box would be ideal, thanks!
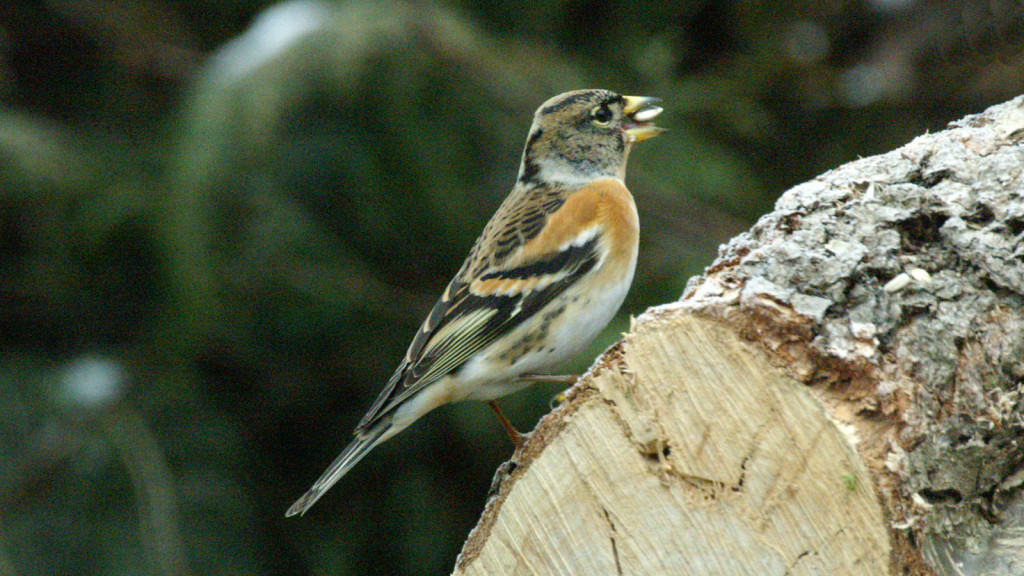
[286,90,664,516]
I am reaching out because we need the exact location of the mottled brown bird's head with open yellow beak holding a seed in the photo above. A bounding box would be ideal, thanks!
[519,90,665,183]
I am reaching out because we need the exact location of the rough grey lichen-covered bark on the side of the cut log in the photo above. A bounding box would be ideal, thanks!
[684,96,1024,574]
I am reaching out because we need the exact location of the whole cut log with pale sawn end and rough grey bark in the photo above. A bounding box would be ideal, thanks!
[456,97,1024,576]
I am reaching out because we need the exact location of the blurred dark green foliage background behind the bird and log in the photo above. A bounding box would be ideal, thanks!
[0,0,1024,575]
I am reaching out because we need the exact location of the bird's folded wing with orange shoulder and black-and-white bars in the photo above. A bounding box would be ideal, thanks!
[357,179,632,429]
